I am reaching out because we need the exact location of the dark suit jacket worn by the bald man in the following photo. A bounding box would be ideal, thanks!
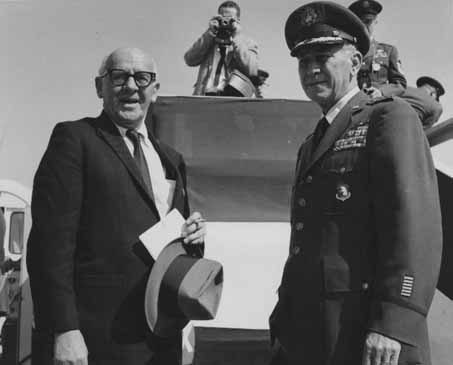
[27,113,189,364]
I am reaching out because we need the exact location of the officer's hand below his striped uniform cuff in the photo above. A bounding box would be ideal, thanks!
[362,332,401,365]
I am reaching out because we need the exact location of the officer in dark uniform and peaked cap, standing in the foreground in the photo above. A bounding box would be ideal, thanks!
[270,1,442,365]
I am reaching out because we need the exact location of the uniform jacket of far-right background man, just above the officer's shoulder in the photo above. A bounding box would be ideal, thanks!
[399,86,442,128]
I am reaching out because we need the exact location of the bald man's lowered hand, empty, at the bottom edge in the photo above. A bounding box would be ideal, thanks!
[54,330,88,365]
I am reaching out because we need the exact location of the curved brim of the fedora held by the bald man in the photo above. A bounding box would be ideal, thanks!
[145,239,189,337]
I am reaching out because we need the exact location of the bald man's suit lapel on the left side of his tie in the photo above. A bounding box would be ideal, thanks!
[93,112,159,216]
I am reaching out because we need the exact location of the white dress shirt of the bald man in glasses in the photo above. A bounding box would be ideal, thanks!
[115,121,176,218]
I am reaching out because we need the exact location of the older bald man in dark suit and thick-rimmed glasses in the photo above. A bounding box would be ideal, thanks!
[27,48,205,365]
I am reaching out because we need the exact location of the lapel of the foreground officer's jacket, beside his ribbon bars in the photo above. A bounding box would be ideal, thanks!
[301,92,369,176]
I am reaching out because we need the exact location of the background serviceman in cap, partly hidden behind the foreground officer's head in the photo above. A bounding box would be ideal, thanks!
[349,0,407,97]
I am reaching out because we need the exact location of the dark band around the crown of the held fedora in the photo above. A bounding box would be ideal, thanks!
[158,255,197,318]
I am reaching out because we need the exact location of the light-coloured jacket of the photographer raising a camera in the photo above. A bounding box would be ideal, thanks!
[184,31,258,95]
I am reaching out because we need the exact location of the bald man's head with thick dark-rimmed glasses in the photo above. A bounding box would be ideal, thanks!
[96,47,159,128]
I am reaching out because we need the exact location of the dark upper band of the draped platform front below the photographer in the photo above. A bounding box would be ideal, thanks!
[154,98,319,222]
